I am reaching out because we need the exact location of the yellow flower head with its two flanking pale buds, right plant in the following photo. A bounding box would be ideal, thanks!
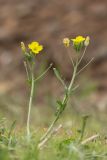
[63,36,90,52]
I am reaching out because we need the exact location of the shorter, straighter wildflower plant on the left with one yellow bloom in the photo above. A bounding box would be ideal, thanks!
[21,42,51,140]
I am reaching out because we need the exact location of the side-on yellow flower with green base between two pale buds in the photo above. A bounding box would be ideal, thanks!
[71,36,86,52]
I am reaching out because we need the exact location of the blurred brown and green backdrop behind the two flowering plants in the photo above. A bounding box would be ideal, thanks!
[0,0,107,126]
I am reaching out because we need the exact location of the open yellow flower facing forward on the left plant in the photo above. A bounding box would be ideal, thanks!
[28,42,43,54]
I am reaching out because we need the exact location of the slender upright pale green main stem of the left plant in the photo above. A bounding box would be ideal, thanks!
[27,65,35,139]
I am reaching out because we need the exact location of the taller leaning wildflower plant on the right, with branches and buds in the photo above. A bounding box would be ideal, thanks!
[38,36,93,148]
